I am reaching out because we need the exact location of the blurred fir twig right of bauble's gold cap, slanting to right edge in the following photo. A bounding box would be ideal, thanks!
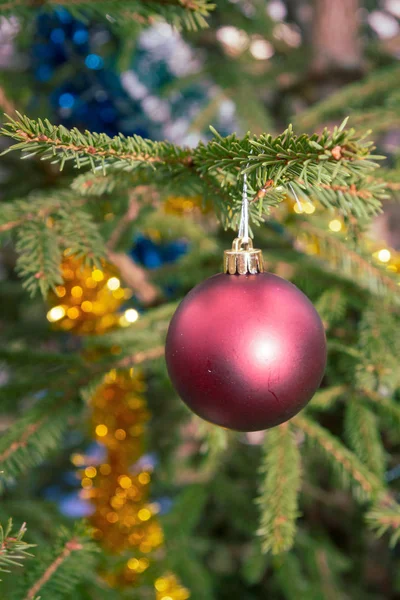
[296,221,400,303]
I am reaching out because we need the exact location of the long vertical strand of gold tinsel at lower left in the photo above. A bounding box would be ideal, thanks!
[82,369,190,600]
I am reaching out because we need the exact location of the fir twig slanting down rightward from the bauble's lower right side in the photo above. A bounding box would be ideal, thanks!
[292,416,385,500]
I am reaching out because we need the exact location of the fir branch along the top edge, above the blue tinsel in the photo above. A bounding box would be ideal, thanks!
[0,0,214,31]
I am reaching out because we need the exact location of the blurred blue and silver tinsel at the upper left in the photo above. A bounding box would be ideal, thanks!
[30,7,235,141]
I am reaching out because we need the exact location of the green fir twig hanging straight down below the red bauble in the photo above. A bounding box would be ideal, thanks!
[257,423,301,554]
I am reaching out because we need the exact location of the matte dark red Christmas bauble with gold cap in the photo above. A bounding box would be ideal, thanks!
[166,238,326,431]
